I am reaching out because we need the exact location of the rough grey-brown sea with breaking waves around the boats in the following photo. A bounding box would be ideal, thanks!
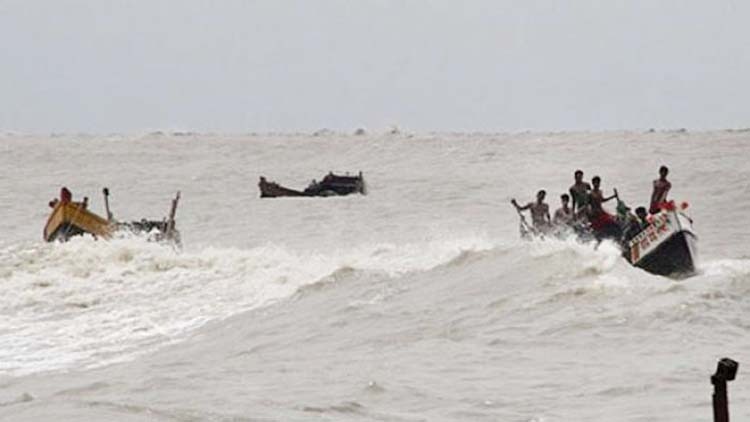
[0,130,750,422]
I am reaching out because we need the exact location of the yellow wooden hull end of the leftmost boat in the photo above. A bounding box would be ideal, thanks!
[44,202,114,242]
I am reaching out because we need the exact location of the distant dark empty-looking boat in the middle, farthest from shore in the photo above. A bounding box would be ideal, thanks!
[258,172,367,198]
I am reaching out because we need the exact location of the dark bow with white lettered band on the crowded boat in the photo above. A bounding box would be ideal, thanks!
[624,211,697,278]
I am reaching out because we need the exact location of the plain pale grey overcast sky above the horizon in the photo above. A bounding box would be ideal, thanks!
[0,0,750,133]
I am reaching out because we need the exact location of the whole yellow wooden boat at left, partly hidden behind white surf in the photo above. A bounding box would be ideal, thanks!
[43,187,180,245]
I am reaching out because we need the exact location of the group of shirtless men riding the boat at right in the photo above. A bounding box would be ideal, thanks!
[511,166,672,242]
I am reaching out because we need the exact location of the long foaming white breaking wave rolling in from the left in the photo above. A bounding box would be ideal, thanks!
[0,236,492,374]
